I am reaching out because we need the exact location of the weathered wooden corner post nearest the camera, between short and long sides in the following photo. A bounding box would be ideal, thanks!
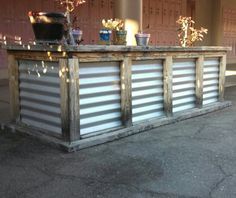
[59,58,80,142]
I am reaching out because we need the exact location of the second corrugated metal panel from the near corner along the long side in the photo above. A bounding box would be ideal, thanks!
[132,60,164,123]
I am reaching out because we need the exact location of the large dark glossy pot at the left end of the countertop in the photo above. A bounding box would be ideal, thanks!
[28,11,66,42]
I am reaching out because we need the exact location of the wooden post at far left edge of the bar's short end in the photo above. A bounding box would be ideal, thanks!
[8,55,20,122]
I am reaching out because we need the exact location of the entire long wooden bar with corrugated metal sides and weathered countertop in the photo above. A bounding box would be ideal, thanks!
[6,45,231,151]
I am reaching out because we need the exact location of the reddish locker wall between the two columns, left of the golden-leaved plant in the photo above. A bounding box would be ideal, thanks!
[143,0,186,46]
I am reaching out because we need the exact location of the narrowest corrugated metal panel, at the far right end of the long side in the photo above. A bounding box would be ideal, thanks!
[203,58,220,105]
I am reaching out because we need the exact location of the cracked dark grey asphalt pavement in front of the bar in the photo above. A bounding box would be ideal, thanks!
[0,87,236,198]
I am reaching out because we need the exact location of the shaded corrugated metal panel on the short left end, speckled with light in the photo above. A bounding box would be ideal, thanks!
[19,60,62,134]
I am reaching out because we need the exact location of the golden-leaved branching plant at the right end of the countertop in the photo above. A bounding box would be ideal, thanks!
[176,16,208,47]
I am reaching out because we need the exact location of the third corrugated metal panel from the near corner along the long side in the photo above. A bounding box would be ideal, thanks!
[173,59,196,113]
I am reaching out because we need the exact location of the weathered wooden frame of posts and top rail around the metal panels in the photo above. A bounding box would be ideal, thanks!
[5,46,228,148]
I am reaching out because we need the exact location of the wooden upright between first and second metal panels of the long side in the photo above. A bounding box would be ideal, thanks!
[120,57,132,127]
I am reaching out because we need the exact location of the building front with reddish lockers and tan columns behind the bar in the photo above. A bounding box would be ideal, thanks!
[0,0,236,79]
